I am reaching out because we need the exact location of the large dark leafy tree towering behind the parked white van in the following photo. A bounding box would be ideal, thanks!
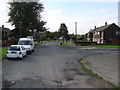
[8,2,46,37]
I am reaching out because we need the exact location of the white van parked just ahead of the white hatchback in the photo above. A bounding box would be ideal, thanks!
[18,38,34,54]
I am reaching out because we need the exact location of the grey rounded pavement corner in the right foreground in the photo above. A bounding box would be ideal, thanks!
[83,53,120,86]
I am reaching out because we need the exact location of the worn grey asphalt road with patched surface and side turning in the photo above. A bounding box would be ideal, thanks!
[2,42,117,88]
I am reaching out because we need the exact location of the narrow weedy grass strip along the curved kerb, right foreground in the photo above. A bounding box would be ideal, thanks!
[80,58,120,90]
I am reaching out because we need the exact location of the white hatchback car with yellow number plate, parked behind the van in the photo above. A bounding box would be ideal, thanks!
[7,45,26,59]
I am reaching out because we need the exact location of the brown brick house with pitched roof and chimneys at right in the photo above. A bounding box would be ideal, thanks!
[86,22,120,45]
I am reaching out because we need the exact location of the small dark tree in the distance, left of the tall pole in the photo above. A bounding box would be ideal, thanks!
[59,23,68,43]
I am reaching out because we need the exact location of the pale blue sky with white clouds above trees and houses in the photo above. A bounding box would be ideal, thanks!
[0,0,118,34]
